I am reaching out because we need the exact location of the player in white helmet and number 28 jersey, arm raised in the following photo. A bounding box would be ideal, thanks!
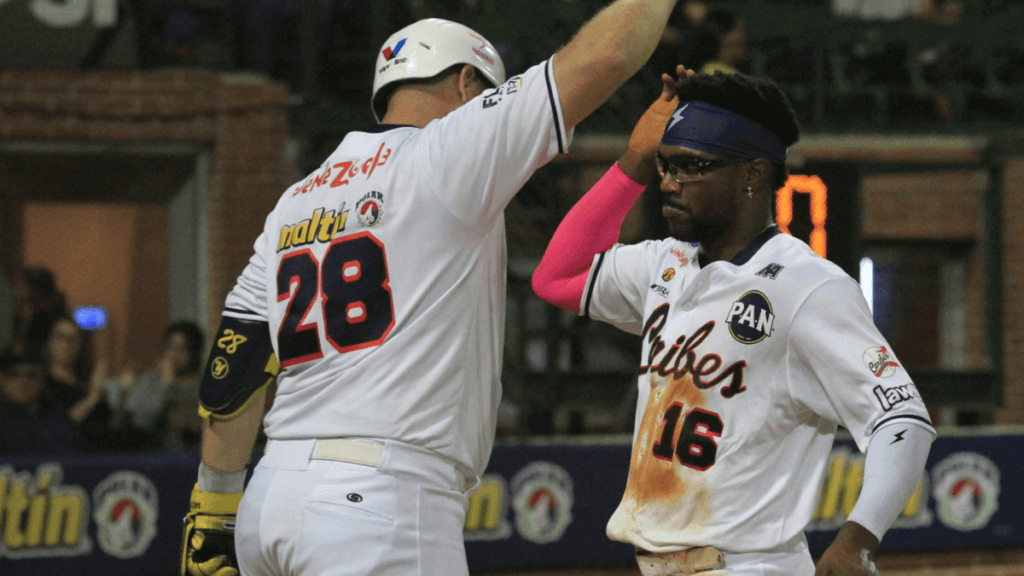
[181,0,692,576]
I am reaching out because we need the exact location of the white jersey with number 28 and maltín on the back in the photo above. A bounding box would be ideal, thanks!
[224,60,571,475]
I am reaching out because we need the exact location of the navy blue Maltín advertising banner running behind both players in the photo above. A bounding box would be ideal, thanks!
[0,428,1024,576]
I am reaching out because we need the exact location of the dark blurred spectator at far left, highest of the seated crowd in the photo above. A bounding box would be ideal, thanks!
[11,266,68,353]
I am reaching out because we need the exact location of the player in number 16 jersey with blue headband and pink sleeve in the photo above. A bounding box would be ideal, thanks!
[534,67,935,576]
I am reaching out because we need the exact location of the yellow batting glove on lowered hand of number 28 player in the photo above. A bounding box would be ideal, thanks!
[181,484,242,576]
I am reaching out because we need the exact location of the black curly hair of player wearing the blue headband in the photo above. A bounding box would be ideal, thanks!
[676,72,800,191]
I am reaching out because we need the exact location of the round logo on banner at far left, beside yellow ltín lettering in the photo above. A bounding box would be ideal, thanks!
[92,470,160,560]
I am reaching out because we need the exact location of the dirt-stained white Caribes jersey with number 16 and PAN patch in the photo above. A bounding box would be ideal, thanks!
[582,228,934,552]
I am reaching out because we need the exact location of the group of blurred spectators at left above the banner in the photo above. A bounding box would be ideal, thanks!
[0,266,206,454]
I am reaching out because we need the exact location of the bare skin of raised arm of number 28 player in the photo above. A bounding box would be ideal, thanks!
[553,0,677,130]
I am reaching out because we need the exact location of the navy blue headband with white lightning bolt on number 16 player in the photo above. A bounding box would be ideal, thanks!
[662,101,785,164]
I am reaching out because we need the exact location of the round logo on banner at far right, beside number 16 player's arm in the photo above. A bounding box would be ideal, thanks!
[932,452,999,532]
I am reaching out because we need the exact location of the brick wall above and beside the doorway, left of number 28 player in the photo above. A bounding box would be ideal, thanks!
[0,70,294,336]
